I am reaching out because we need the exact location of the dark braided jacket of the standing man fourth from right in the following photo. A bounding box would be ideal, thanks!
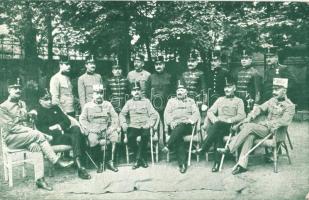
[180,69,206,98]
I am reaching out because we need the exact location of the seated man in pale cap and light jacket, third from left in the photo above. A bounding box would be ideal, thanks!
[79,84,120,173]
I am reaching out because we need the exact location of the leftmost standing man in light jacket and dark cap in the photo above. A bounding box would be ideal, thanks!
[50,56,75,117]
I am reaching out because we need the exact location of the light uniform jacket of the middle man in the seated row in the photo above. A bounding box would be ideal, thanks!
[119,98,158,128]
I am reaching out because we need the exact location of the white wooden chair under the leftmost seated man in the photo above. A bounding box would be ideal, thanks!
[0,128,44,187]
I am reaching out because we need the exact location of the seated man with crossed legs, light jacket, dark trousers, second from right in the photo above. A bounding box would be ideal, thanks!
[197,77,246,172]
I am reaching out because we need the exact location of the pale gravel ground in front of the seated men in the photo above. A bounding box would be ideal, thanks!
[0,122,309,200]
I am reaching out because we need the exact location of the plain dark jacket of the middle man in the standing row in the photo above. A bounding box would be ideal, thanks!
[150,72,174,111]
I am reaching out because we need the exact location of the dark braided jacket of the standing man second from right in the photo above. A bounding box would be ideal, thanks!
[236,67,261,103]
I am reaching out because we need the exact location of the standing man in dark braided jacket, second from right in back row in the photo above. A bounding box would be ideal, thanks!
[236,50,261,113]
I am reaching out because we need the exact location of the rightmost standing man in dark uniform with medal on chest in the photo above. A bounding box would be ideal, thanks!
[262,47,296,102]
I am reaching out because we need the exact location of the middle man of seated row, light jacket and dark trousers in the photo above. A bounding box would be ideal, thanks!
[119,82,158,169]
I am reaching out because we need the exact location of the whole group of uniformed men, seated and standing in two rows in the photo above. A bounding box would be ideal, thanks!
[0,47,295,190]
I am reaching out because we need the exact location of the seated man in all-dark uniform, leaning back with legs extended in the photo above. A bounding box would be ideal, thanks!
[35,89,91,179]
